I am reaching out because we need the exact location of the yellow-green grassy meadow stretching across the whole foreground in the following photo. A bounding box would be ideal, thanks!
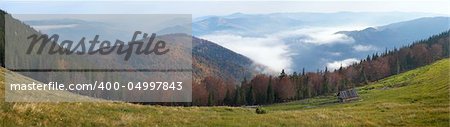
[0,59,450,127]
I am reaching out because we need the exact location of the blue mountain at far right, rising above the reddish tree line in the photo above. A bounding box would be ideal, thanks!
[337,17,450,49]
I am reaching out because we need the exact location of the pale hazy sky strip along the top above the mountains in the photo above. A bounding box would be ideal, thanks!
[0,0,450,18]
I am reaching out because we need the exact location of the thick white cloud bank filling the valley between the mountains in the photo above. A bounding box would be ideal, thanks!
[200,28,362,71]
